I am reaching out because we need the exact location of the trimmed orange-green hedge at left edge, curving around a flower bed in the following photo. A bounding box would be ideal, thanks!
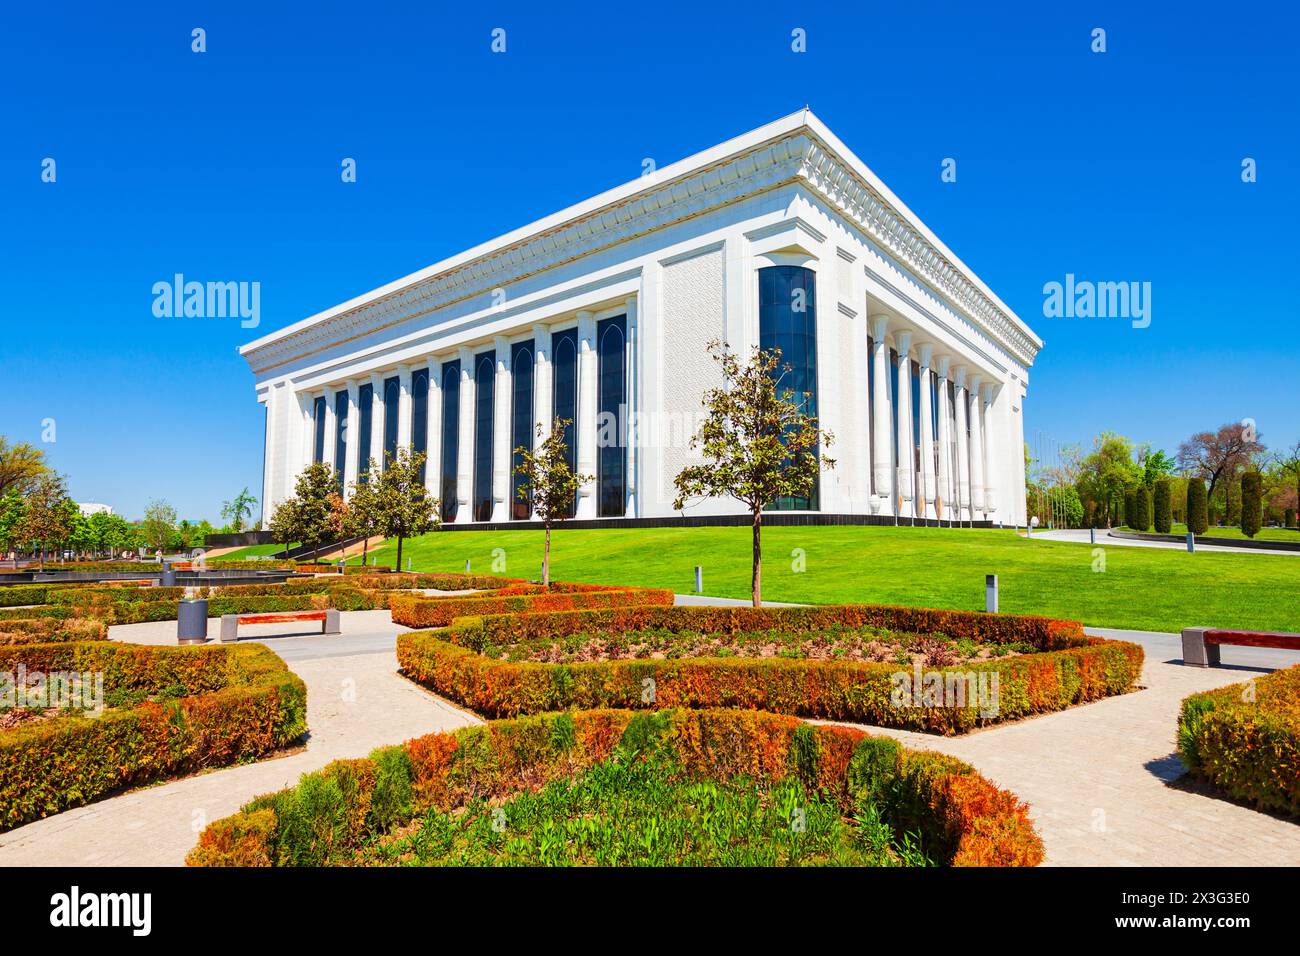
[0,641,307,831]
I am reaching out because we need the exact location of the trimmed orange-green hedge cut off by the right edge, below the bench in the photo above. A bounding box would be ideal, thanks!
[1178,665,1300,817]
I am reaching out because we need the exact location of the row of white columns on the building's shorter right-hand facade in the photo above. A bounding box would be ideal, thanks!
[871,316,998,520]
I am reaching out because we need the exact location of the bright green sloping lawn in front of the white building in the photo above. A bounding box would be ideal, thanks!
[354,527,1300,631]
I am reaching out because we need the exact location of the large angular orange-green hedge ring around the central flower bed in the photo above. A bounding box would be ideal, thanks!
[394,600,1143,735]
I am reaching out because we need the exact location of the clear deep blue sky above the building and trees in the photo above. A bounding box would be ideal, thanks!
[0,3,1300,523]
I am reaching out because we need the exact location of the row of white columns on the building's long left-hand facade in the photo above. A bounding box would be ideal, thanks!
[289,298,637,524]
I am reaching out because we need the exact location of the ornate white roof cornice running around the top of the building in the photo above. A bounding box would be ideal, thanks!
[239,111,1043,375]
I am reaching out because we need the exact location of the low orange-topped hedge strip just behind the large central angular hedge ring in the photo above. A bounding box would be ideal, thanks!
[389,584,673,627]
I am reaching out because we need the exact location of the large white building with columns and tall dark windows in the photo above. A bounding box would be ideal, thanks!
[241,111,1043,524]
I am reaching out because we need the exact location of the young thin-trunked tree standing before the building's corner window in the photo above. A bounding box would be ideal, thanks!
[673,341,835,607]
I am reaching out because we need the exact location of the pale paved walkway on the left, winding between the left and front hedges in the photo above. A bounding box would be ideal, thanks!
[0,611,478,866]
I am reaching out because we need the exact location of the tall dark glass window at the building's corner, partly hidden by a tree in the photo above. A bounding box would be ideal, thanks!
[758,265,820,511]
